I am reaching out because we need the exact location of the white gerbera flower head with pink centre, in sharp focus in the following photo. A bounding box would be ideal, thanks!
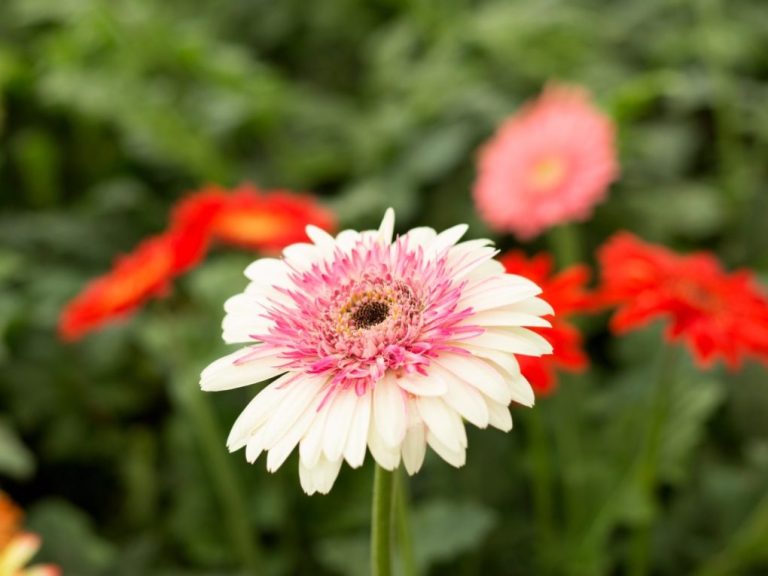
[201,209,552,494]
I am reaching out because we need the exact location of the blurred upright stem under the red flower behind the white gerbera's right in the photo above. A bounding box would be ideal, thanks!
[528,406,556,574]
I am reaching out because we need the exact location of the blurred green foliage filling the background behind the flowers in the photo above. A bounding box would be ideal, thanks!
[0,0,768,576]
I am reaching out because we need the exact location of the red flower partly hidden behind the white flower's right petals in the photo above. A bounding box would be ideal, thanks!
[500,251,591,394]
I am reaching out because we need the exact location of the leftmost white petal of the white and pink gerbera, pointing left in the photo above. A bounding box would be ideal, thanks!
[200,347,285,391]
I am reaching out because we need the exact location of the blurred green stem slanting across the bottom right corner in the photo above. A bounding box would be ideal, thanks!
[695,494,768,576]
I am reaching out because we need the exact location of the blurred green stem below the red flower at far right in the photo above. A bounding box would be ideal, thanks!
[629,343,681,576]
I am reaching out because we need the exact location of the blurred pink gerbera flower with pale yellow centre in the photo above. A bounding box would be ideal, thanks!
[474,86,618,239]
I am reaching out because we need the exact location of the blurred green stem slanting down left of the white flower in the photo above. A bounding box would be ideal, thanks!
[171,362,262,574]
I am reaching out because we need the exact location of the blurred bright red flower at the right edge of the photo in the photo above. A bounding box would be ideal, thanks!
[598,232,768,368]
